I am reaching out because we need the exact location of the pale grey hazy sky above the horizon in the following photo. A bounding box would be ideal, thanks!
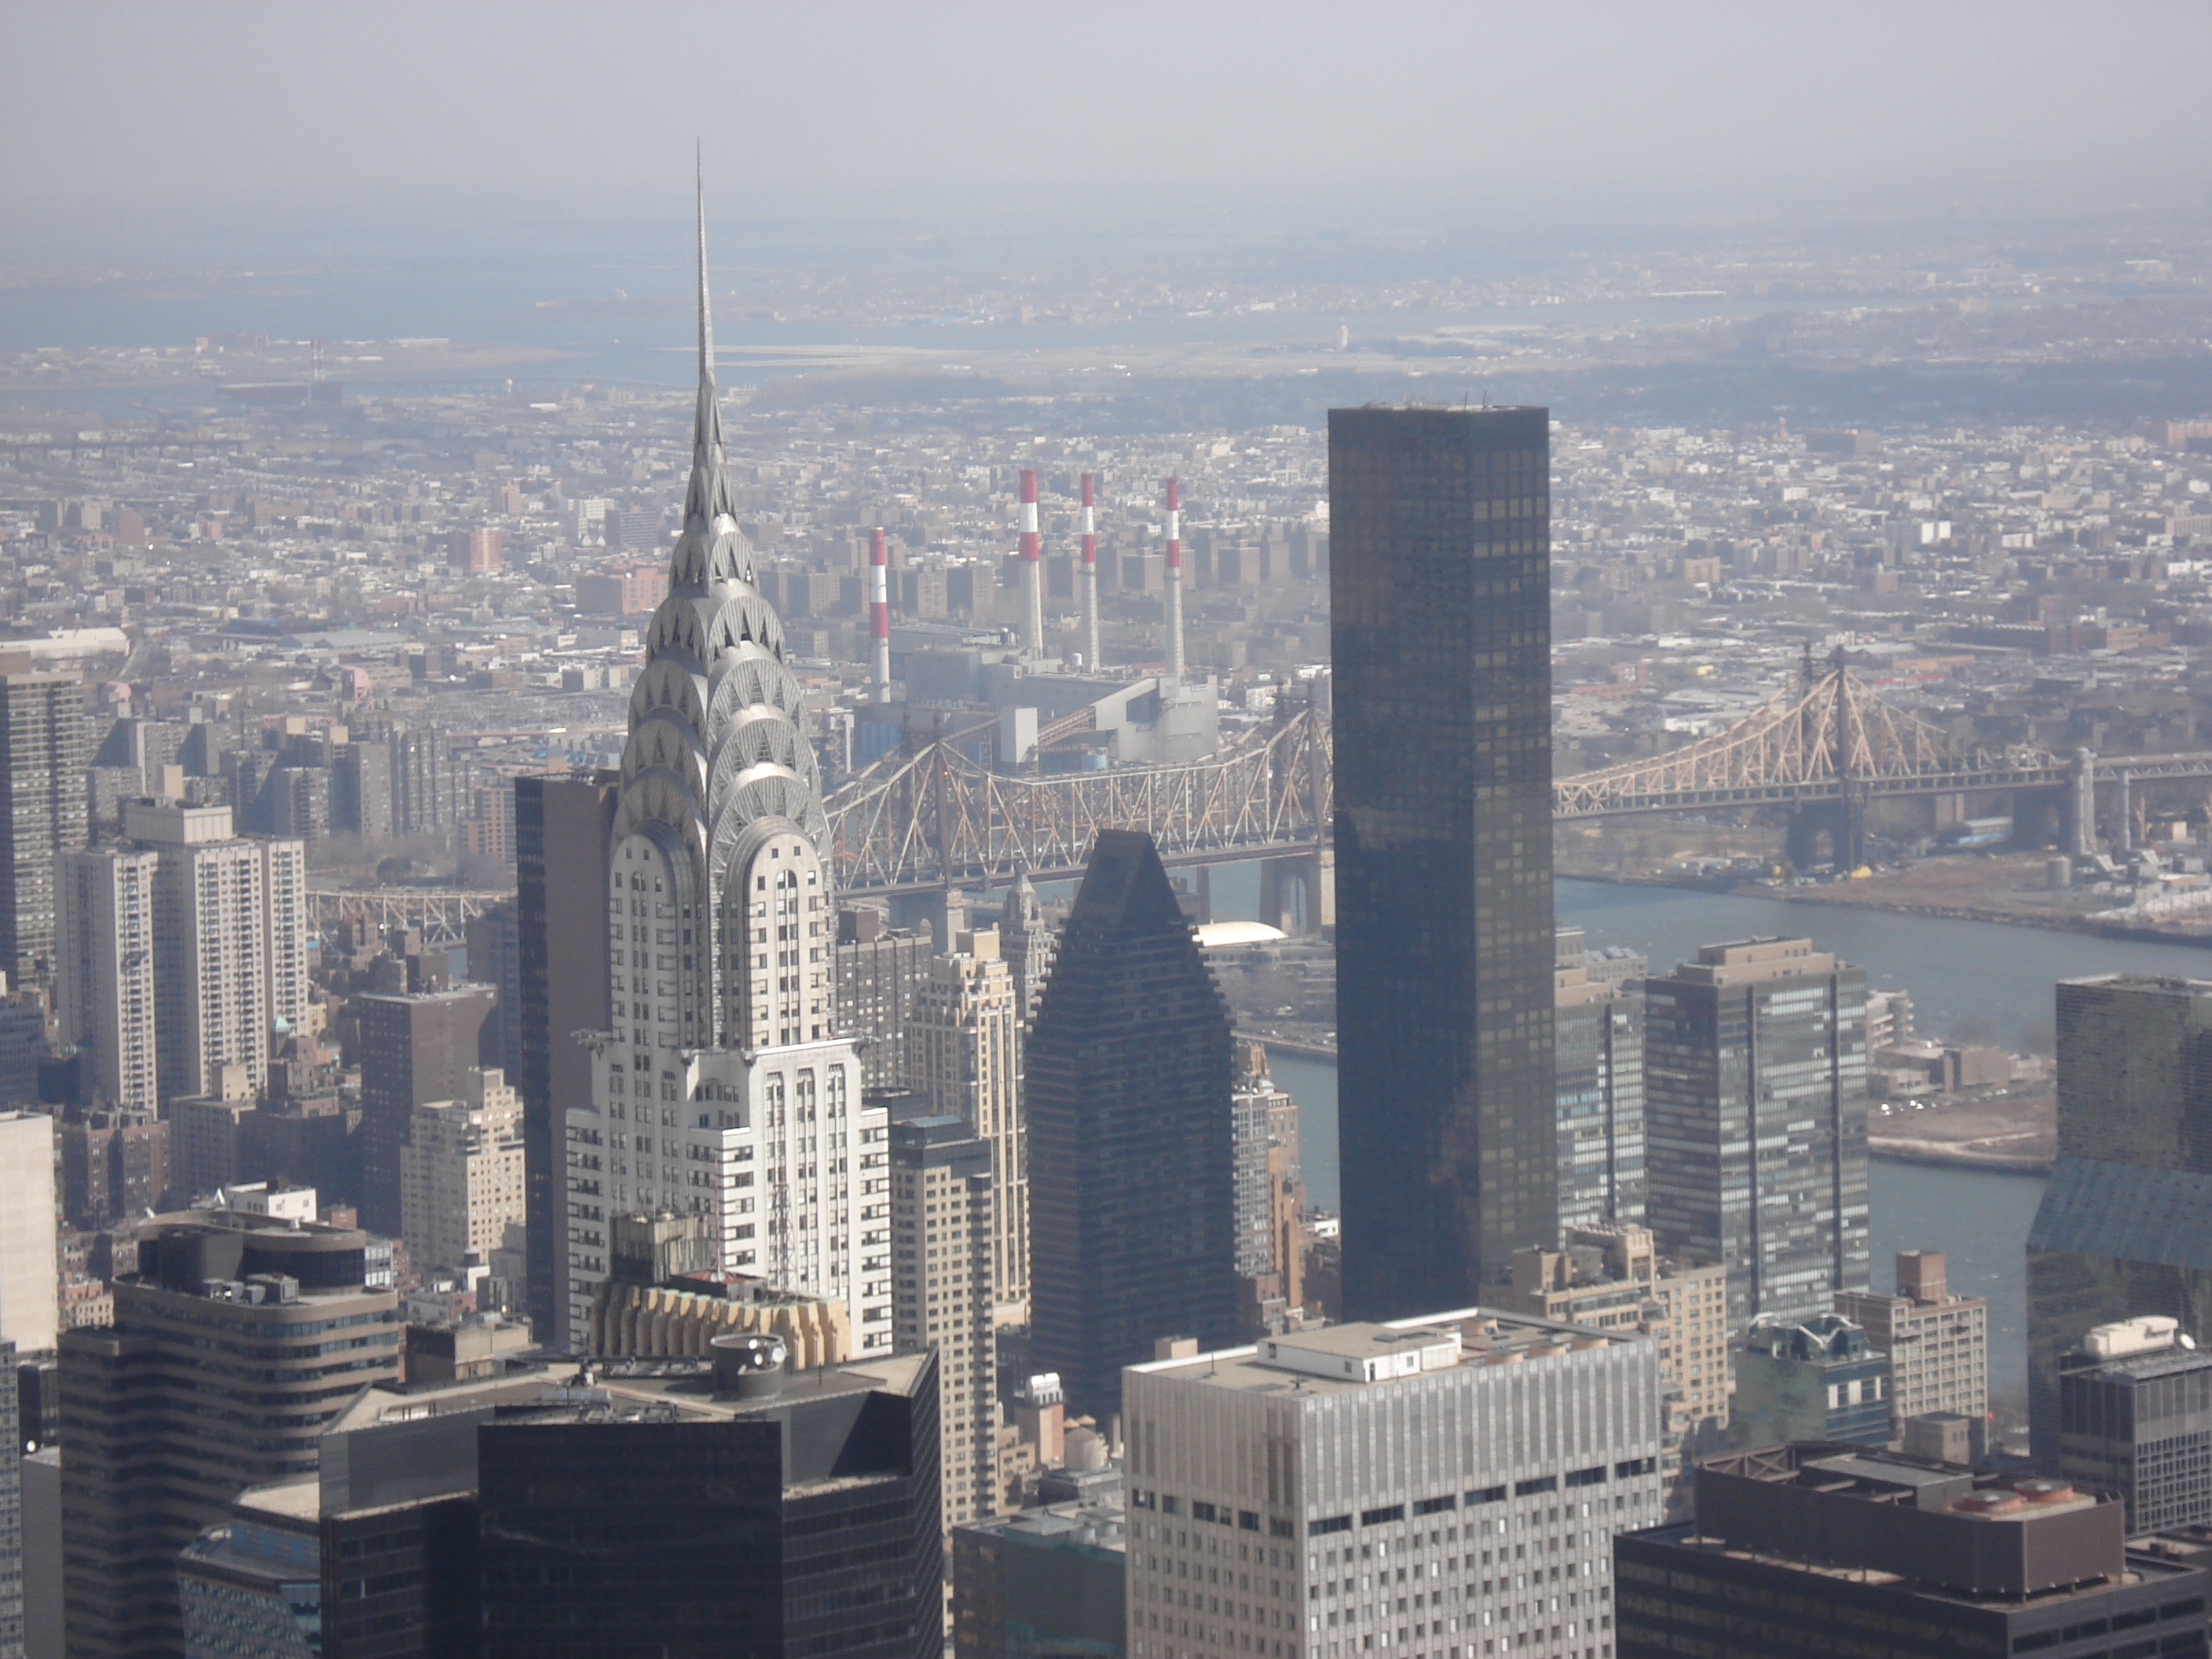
[0,0,2212,257]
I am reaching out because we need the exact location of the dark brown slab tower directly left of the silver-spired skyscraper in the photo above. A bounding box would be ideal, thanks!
[511,772,619,1347]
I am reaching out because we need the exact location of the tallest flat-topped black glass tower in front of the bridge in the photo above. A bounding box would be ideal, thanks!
[1329,407,1559,1318]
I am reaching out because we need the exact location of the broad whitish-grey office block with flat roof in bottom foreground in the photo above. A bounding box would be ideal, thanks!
[1122,1307,1661,1659]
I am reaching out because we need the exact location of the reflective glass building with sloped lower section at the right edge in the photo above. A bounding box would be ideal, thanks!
[2028,973,2212,1473]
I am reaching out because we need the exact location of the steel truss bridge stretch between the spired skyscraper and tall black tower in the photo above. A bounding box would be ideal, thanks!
[827,708,1334,894]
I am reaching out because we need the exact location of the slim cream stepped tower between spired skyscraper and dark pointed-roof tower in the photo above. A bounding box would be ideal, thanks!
[907,927,1028,1318]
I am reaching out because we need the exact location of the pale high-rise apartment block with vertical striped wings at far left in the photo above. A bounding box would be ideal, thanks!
[57,800,309,1108]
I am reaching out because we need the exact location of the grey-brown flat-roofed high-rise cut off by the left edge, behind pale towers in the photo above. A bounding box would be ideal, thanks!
[0,675,90,984]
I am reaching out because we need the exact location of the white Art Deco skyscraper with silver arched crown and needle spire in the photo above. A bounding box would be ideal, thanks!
[566,175,892,1358]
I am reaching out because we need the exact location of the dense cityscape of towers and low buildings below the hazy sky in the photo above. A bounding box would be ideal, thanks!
[0,185,2212,1659]
